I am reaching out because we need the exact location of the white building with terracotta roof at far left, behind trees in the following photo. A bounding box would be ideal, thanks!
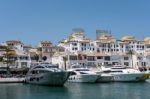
[0,40,31,68]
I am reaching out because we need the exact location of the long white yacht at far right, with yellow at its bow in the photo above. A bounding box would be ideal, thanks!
[98,65,148,82]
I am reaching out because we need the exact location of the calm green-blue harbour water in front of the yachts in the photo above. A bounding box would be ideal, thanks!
[0,82,150,99]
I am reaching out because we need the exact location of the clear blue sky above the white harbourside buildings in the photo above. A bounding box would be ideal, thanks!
[0,0,150,45]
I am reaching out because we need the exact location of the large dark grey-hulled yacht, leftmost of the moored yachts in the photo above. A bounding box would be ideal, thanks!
[25,63,71,86]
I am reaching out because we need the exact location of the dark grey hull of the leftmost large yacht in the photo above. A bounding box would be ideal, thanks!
[26,72,70,86]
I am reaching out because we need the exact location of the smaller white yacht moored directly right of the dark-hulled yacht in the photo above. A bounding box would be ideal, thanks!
[68,65,99,83]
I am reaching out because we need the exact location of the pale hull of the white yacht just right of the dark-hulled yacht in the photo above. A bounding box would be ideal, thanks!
[68,74,99,83]
